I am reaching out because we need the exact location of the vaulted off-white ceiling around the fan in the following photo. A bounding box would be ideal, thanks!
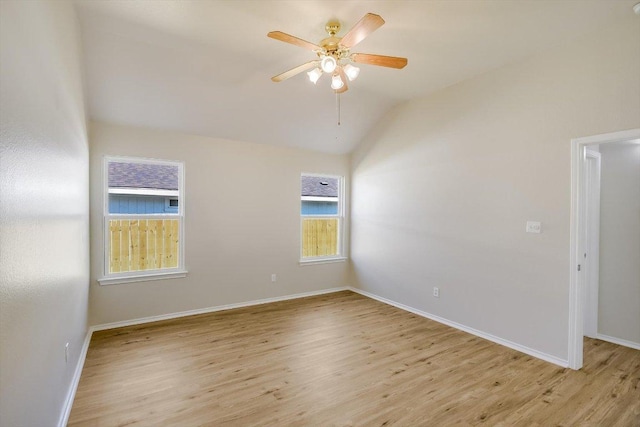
[76,0,638,153]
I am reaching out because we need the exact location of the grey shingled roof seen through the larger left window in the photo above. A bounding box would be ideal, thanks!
[109,162,178,190]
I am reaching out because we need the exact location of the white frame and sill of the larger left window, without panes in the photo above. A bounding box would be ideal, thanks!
[98,155,188,285]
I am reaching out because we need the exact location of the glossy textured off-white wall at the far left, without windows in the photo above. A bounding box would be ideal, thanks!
[0,1,89,427]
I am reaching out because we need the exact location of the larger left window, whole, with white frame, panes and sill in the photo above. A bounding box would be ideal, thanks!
[100,157,186,284]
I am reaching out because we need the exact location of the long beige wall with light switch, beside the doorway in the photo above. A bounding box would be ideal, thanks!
[351,13,640,362]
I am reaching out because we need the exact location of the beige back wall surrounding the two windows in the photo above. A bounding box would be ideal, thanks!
[89,122,349,325]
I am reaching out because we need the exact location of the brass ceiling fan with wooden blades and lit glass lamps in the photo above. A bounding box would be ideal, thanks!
[267,13,407,93]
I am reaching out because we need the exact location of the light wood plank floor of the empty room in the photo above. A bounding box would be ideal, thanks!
[69,292,640,426]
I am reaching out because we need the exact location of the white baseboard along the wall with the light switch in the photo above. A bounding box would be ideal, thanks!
[349,287,569,368]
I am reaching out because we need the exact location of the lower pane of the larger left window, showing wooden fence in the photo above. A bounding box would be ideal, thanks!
[109,219,180,273]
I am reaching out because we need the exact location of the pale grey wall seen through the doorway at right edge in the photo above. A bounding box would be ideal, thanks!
[598,143,640,346]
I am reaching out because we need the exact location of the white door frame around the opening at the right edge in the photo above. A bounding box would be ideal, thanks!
[568,129,640,370]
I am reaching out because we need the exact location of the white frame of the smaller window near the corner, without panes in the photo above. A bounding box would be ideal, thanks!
[298,172,347,265]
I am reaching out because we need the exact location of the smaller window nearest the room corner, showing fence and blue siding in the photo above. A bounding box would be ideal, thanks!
[300,174,344,262]
